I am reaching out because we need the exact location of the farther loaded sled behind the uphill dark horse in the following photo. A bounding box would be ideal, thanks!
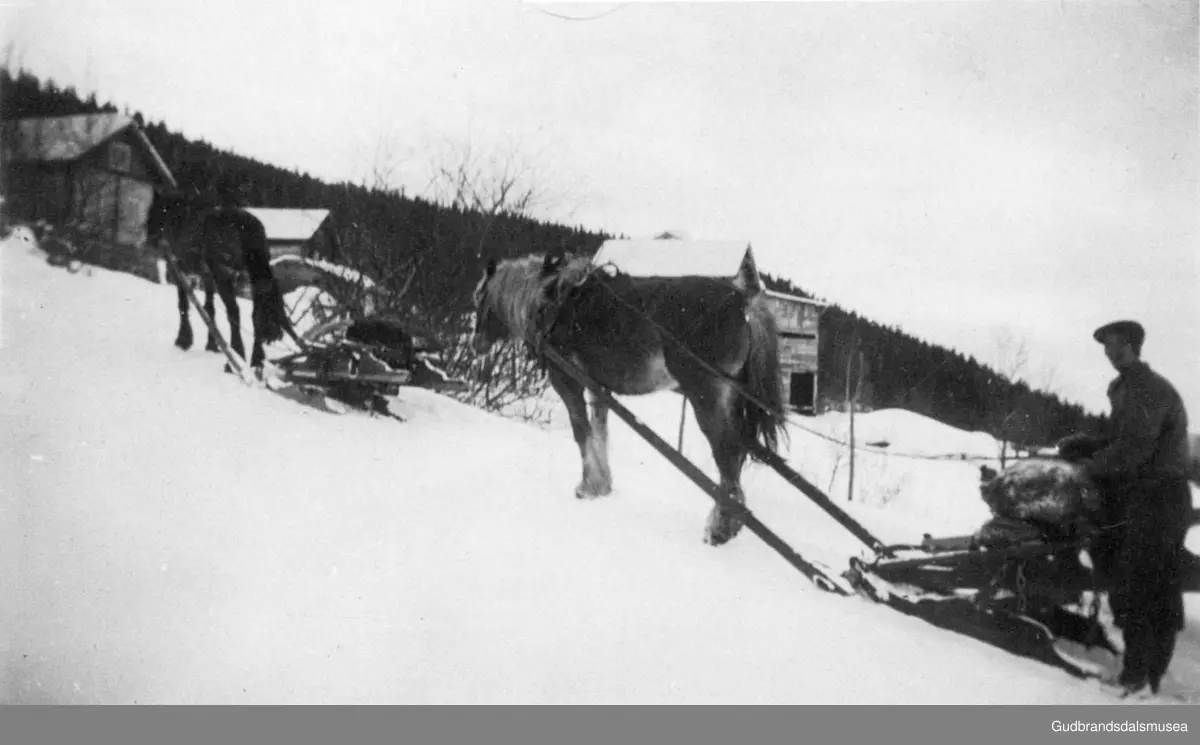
[272,318,466,413]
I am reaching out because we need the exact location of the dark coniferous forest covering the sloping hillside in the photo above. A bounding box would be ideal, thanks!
[0,70,1104,446]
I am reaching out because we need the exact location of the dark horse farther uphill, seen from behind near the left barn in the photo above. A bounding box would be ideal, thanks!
[146,192,292,368]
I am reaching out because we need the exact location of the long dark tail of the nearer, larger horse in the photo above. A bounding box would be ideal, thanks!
[738,295,787,459]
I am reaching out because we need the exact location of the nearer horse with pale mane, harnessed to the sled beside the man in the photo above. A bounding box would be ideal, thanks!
[474,254,786,546]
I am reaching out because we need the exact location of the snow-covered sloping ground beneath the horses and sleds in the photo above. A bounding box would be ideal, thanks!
[0,227,1200,704]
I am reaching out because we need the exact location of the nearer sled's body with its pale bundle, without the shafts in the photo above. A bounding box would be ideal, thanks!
[845,459,1116,675]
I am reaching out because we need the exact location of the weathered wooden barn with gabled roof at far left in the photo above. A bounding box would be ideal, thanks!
[0,113,174,246]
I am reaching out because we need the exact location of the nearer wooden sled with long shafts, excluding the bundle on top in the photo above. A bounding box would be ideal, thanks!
[541,347,1137,678]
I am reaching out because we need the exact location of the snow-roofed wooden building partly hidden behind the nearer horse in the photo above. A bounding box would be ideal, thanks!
[592,234,824,414]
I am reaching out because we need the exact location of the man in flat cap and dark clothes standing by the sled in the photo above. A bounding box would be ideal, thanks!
[1060,320,1192,695]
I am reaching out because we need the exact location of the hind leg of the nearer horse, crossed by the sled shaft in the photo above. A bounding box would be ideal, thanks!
[684,378,746,546]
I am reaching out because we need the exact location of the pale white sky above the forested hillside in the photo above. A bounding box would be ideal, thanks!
[0,0,1200,419]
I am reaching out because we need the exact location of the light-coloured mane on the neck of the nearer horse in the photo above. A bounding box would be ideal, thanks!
[486,249,594,342]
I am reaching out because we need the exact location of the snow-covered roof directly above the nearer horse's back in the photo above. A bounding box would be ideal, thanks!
[592,239,757,277]
